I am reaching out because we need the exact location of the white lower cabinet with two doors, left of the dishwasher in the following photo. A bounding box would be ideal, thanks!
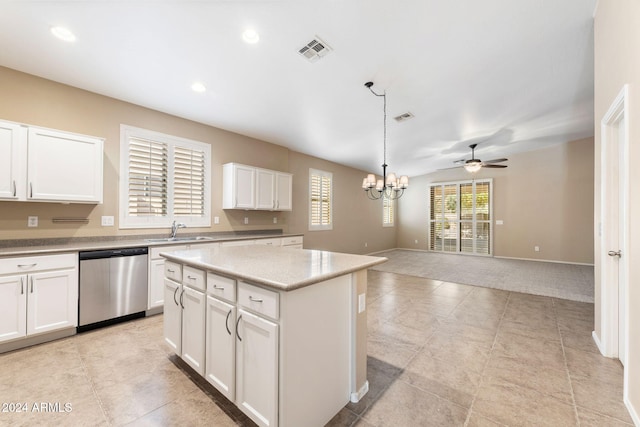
[0,253,78,342]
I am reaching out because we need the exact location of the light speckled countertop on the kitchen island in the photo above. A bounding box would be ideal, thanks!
[160,245,387,291]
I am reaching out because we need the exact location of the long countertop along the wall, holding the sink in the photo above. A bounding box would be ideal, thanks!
[0,231,304,257]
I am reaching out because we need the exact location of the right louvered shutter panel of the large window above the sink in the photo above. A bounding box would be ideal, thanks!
[173,147,205,216]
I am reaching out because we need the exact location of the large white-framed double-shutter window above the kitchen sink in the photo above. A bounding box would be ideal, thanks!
[120,125,211,228]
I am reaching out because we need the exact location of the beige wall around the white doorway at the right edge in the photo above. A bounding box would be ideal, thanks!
[594,0,640,424]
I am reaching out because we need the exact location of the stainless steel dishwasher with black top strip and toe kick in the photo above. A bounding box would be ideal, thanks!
[78,247,148,332]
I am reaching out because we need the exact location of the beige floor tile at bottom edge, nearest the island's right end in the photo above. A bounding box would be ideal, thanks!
[363,381,467,427]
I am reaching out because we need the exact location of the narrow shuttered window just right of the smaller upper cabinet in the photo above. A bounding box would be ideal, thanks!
[309,169,333,231]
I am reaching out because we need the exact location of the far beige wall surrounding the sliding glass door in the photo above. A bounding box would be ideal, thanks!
[398,138,593,264]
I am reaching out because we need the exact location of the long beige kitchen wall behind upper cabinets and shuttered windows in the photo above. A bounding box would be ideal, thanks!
[0,67,395,253]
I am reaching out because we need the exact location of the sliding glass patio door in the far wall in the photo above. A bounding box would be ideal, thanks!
[429,179,493,255]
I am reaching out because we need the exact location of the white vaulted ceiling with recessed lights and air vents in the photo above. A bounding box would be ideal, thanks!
[0,0,596,176]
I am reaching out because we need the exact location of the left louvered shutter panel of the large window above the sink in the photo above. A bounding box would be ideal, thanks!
[127,138,168,216]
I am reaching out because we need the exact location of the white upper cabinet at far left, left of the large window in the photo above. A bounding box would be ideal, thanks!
[0,121,103,203]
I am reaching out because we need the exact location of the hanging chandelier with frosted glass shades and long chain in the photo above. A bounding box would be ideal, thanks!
[362,82,409,200]
